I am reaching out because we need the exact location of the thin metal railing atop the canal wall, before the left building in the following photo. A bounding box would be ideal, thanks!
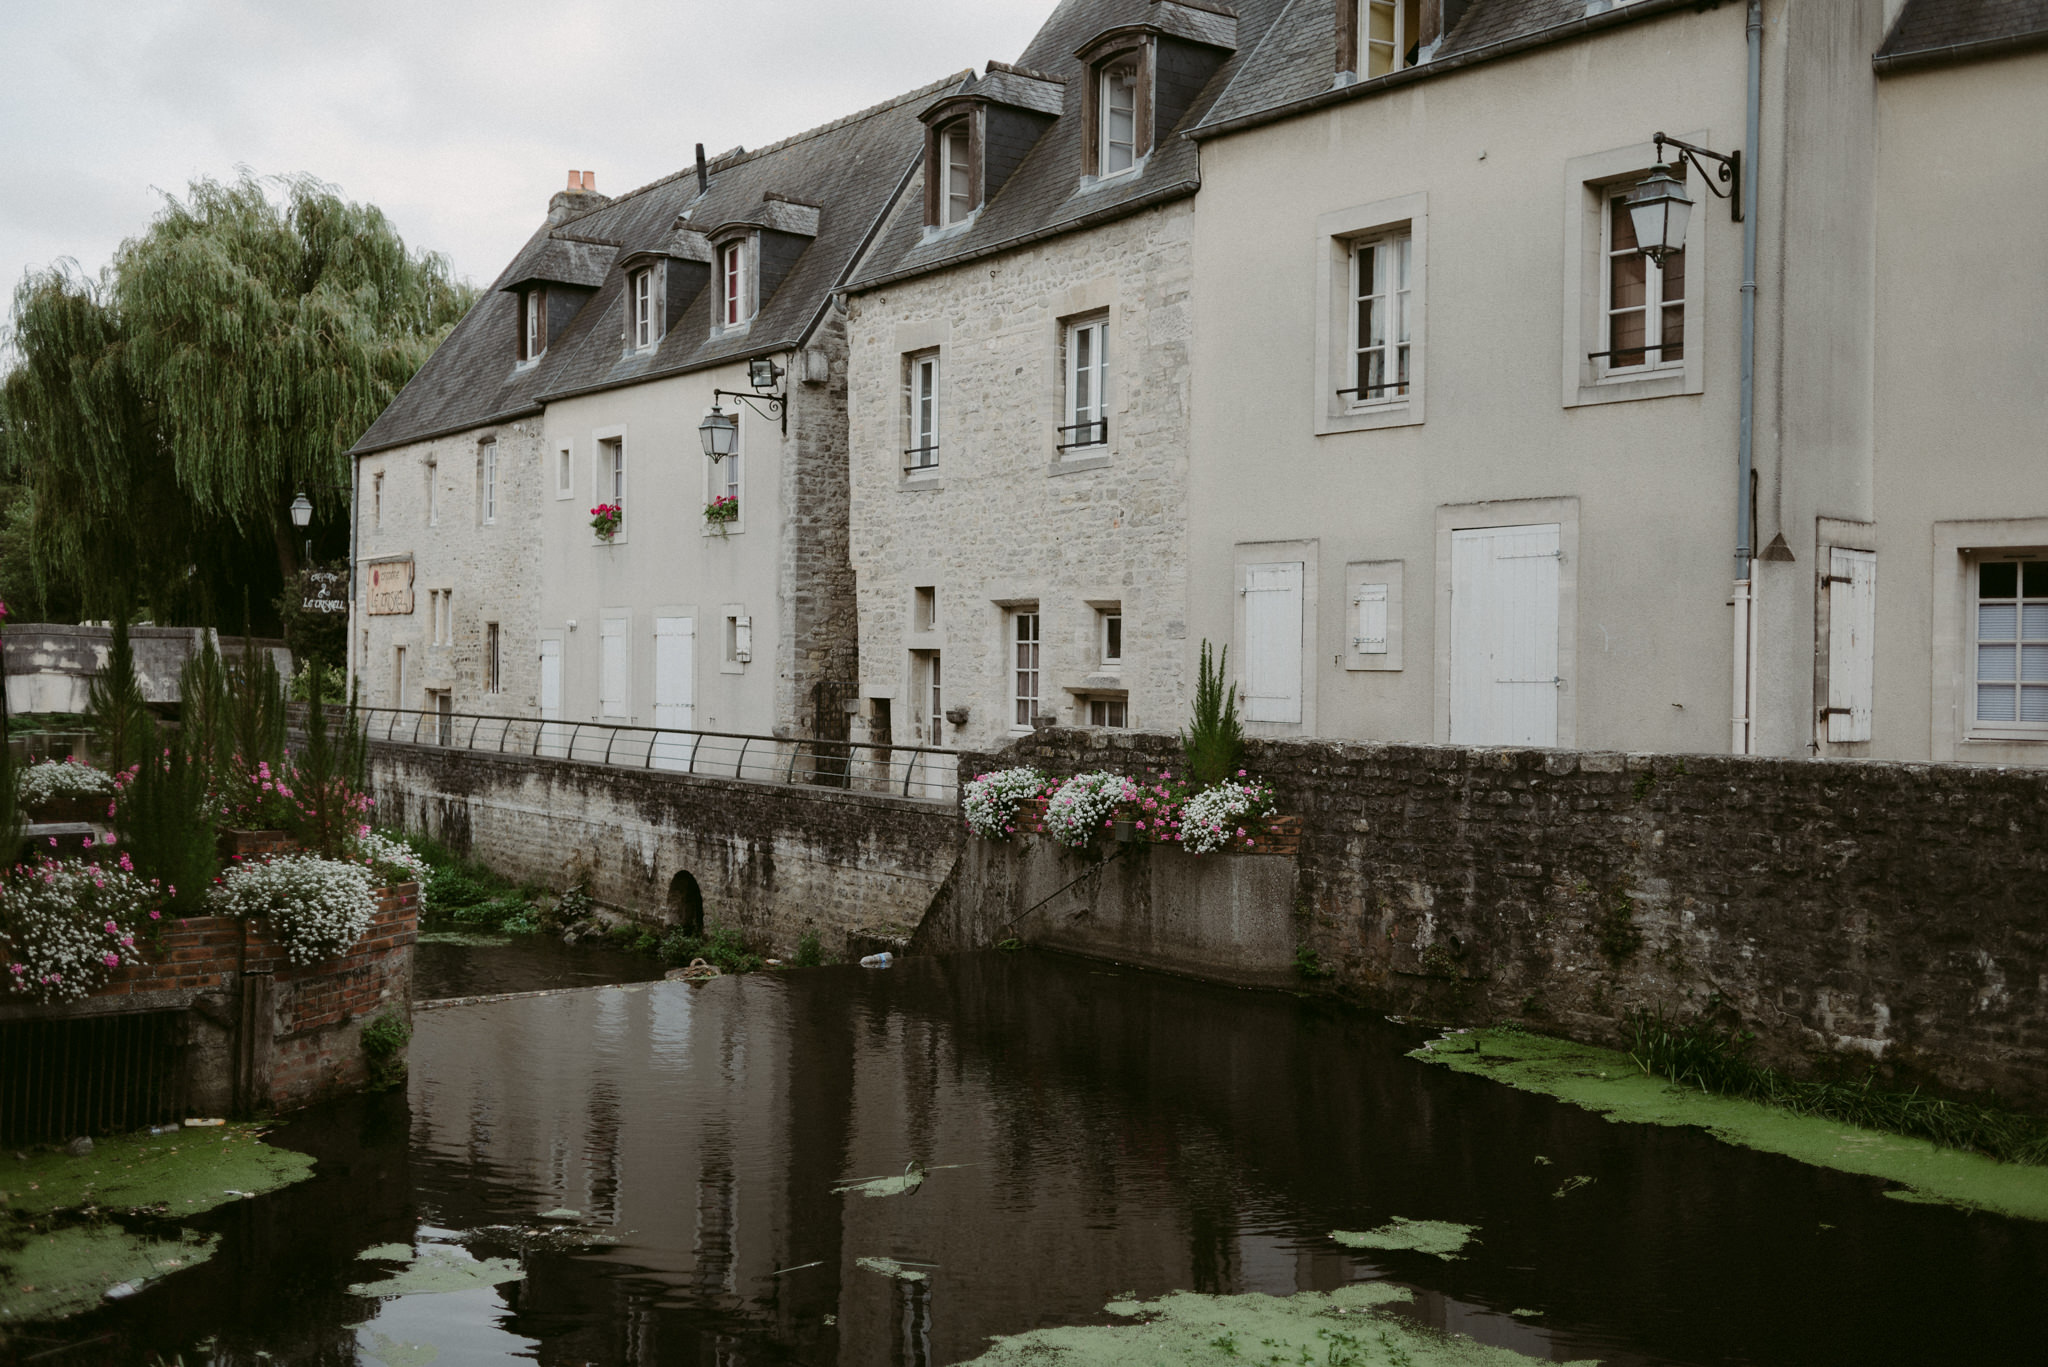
[358,707,958,803]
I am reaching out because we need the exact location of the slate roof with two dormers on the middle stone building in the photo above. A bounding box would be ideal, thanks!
[852,0,1286,289]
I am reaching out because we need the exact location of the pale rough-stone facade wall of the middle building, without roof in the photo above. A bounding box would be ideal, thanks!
[848,203,1194,746]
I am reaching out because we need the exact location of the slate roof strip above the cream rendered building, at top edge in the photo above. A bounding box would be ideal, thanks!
[1192,0,1703,139]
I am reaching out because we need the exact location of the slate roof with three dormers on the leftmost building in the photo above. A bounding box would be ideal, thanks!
[352,74,967,455]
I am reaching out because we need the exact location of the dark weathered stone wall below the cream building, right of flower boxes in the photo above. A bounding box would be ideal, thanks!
[948,732,2048,1109]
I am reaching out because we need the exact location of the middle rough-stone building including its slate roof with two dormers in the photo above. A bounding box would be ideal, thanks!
[848,0,1280,746]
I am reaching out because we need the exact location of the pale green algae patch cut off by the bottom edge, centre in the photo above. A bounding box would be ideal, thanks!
[963,1281,1597,1367]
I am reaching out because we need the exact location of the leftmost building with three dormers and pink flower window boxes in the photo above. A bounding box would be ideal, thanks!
[350,78,958,741]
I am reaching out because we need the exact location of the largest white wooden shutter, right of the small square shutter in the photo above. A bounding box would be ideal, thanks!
[1450,523,1563,746]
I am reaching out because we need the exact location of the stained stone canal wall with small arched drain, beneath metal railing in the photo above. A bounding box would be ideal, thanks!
[371,742,958,953]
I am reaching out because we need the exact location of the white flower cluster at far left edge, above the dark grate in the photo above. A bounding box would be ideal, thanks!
[0,857,162,1002]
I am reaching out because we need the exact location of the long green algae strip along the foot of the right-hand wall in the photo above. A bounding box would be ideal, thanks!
[1409,1031,2048,1221]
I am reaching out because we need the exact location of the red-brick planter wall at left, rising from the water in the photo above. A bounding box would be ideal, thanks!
[0,883,420,1115]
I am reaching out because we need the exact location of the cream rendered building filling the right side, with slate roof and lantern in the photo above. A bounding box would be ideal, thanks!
[1188,0,2048,760]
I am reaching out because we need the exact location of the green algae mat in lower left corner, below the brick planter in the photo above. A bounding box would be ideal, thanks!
[0,1125,313,1326]
